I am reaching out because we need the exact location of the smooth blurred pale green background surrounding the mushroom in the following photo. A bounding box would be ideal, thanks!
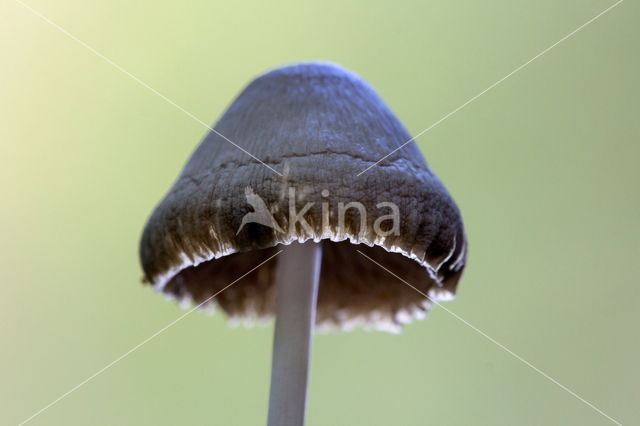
[0,0,640,425]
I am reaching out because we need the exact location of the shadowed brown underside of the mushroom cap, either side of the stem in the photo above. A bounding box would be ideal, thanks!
[154,236,461,332]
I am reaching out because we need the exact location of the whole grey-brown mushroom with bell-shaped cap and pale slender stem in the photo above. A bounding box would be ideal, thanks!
[140,62,466,426]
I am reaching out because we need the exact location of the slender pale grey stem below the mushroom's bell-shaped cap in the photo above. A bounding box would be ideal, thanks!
[268,241,322,426]
